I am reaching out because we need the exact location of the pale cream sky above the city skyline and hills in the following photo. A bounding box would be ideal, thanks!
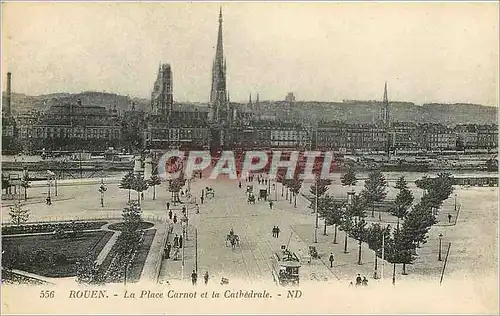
[2,2,499,106]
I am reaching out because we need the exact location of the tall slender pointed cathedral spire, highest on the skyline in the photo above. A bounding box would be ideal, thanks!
[210,8,231,126]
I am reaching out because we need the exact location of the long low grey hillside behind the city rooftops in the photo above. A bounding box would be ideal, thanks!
[2,91,497,125]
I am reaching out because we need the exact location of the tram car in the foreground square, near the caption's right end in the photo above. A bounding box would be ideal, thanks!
[272,250,300,286]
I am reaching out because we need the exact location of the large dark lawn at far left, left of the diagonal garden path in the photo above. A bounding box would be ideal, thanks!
[2,231,113,277]
